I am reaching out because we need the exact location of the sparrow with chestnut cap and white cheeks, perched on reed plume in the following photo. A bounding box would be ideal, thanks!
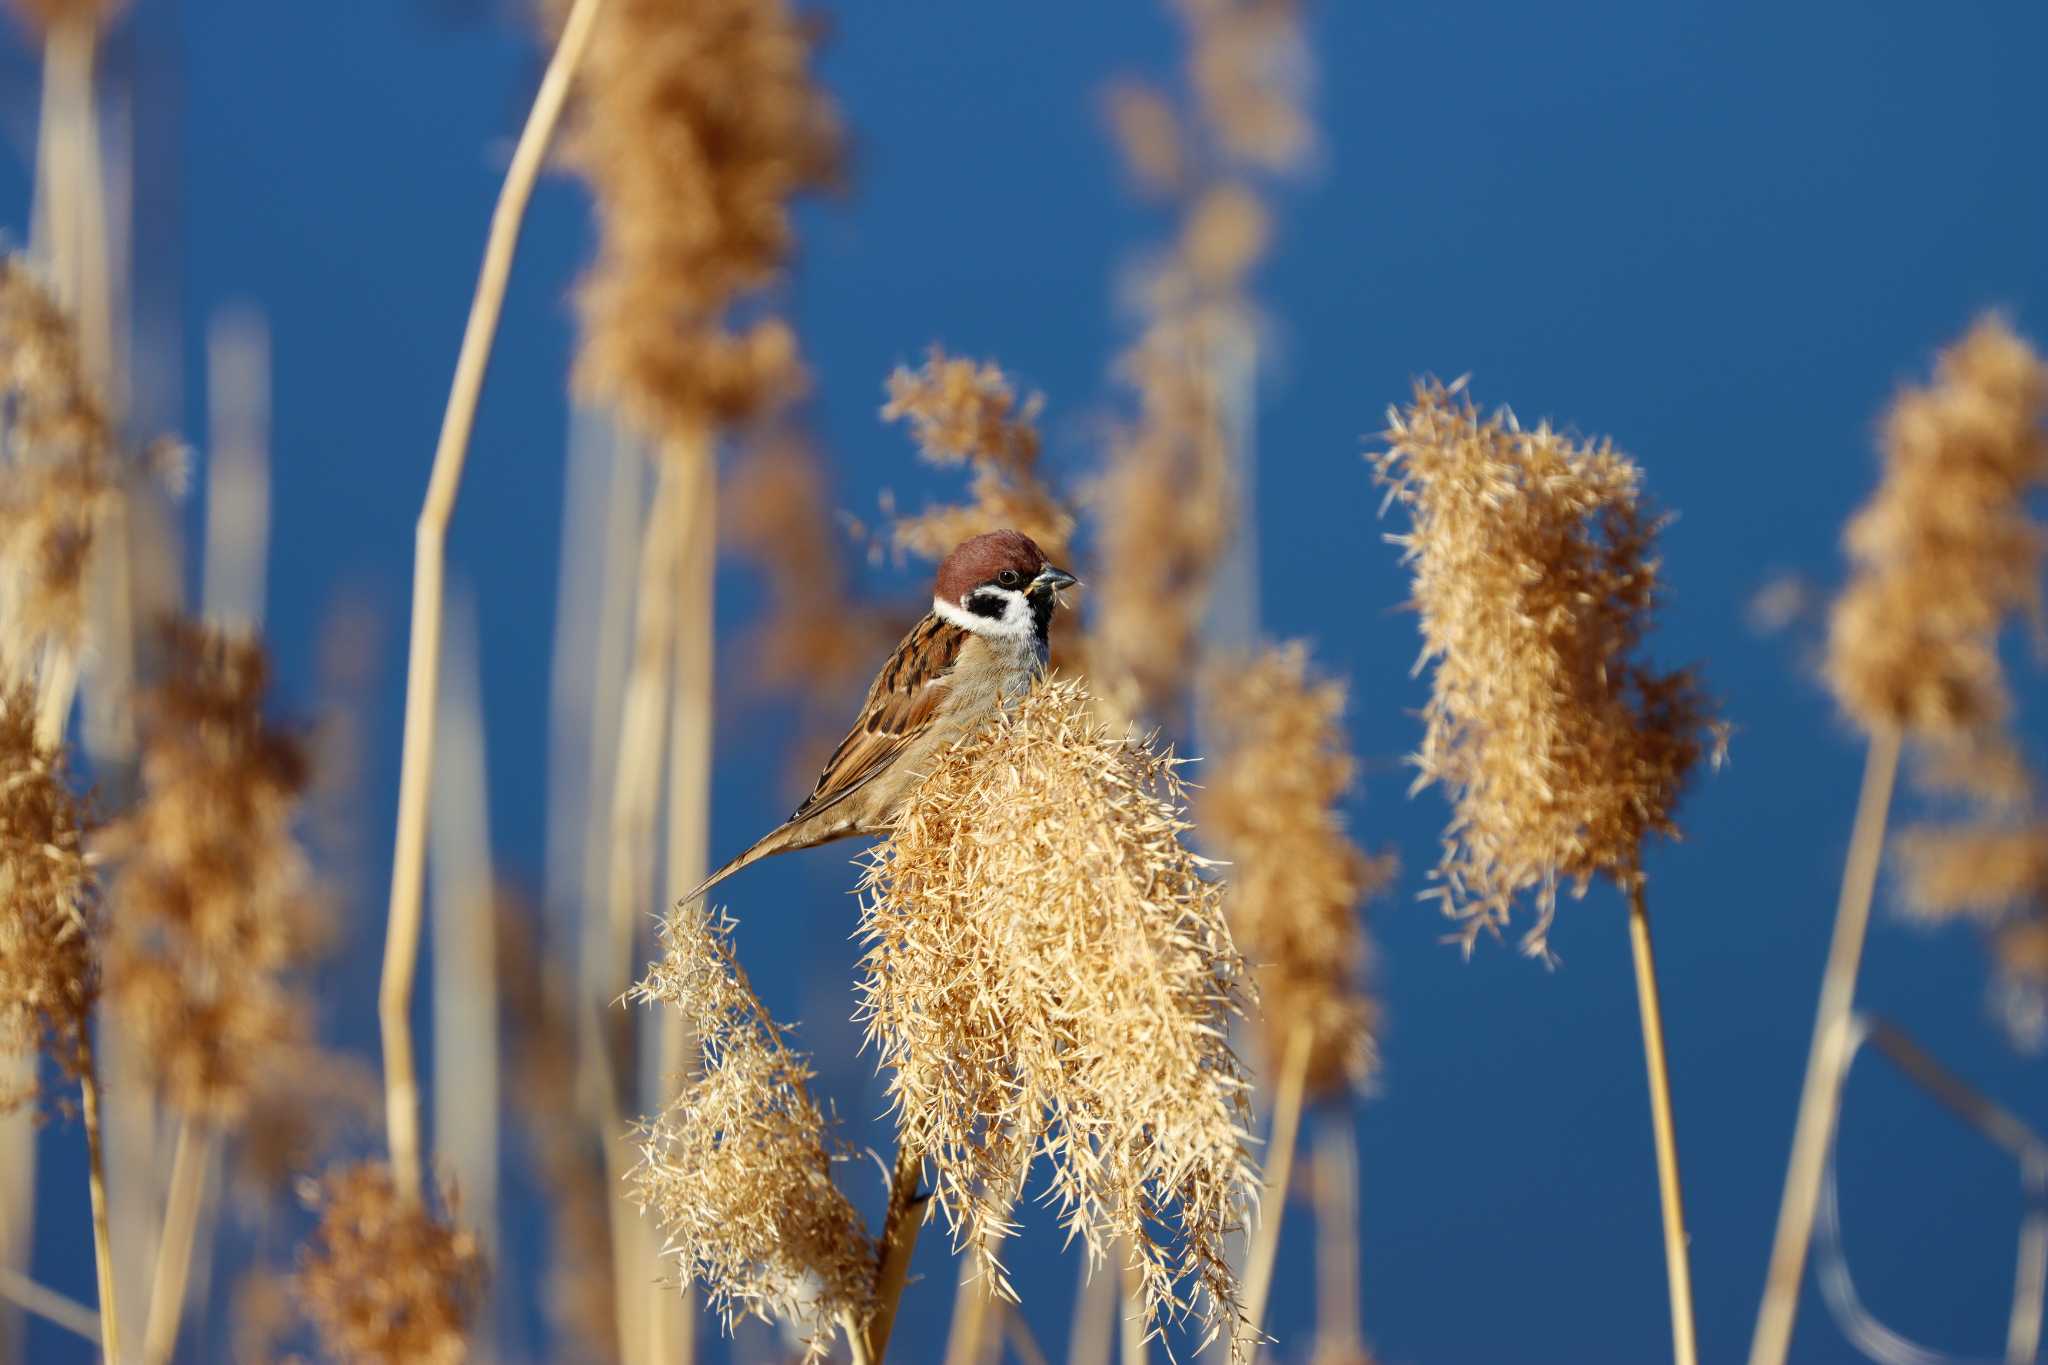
[682,530,1079,905]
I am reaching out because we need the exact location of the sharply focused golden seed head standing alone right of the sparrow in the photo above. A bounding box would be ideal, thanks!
[1372,381,1720,954]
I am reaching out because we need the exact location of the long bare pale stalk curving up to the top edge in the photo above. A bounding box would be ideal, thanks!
[377,0,604,1201]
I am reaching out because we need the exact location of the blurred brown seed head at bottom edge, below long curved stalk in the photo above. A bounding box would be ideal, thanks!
[293,1162,485,1365]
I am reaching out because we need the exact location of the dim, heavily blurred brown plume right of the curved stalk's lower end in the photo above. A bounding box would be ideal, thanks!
[498,894,618,1361]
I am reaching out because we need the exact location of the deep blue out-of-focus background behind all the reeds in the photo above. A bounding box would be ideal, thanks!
[0,0,2048,1363]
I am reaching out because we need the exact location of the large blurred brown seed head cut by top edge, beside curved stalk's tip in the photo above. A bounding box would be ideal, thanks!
[567,0,840,436]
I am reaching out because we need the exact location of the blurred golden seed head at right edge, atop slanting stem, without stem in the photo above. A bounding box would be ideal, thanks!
[1827,315,2048,739]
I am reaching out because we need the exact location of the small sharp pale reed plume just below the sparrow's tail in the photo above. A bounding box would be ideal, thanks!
[629,902,874,1359]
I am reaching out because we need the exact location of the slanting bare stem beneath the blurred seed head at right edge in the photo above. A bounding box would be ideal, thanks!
[1749,731,1898,1365]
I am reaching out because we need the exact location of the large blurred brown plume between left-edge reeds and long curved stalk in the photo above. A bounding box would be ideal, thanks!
[106,622,326,1126]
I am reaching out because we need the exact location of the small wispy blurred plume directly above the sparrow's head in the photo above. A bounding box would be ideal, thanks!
[883,356,1073,563]
